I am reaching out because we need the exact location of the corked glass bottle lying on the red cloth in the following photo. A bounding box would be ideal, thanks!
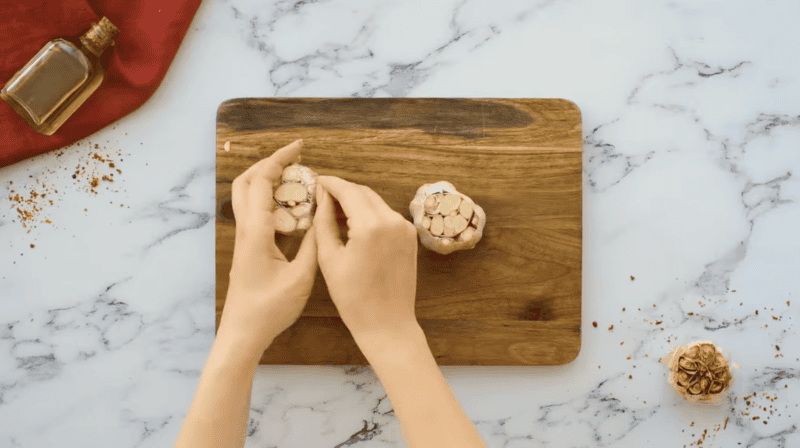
[0,17,119,135]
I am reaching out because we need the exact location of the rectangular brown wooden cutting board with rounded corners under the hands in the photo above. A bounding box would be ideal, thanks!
[216,98,582,365]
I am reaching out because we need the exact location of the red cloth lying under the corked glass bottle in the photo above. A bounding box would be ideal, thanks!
[0,0,200,167]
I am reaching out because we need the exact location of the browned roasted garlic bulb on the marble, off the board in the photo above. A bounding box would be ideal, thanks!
[667,341,732,403]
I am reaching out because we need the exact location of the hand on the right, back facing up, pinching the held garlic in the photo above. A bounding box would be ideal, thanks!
[314,176,418,342]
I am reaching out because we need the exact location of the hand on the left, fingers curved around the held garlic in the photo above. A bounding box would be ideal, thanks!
[218,140,317,356]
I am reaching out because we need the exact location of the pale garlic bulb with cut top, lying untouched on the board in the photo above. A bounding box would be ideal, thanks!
[408,181,486,255]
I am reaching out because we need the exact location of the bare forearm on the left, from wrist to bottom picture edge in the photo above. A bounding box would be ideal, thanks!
[175,331,261,448]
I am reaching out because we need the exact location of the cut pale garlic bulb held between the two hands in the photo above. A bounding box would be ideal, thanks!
[272,163,317,236]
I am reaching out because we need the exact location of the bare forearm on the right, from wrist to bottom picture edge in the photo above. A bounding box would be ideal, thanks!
[357,325,486,448]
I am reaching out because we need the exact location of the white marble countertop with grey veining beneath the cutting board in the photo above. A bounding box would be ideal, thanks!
[0,0,800,448]
